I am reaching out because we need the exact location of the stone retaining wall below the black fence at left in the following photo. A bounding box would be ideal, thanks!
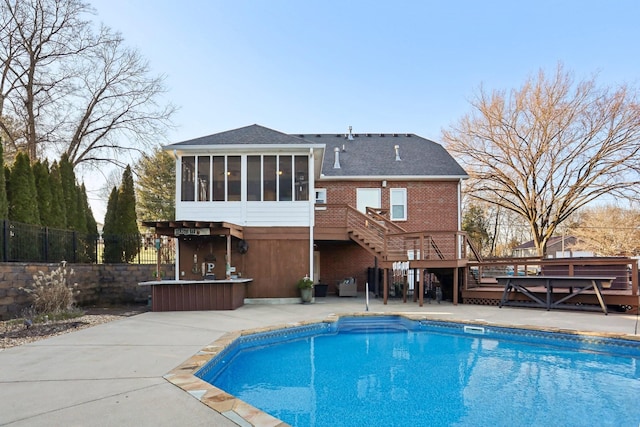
[0,262,174,320]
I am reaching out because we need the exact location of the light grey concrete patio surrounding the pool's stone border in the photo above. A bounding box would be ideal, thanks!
[0,297,637,427]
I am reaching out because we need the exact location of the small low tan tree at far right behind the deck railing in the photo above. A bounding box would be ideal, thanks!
[567,205,640,256]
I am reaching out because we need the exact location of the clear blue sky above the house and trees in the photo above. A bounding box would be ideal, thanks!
[88,0,640,221]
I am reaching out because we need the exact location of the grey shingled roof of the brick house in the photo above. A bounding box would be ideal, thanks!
[165,125,468,180]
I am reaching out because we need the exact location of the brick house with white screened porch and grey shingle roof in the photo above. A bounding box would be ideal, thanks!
[146,125,467,308]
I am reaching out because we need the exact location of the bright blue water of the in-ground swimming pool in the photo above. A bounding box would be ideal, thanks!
[196,317,640,427]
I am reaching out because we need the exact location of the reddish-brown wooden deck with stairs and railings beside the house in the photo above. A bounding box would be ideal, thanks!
[314,204,640,312]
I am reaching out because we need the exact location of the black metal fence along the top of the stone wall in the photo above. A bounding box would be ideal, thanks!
[0,219,175,264]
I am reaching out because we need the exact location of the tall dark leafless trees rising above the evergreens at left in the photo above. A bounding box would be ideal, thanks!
[0,0,174,170]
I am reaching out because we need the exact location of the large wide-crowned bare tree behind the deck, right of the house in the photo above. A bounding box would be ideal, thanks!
[443,65,640,255]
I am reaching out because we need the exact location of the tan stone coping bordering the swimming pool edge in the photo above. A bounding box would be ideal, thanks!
[163,312,640,427]
